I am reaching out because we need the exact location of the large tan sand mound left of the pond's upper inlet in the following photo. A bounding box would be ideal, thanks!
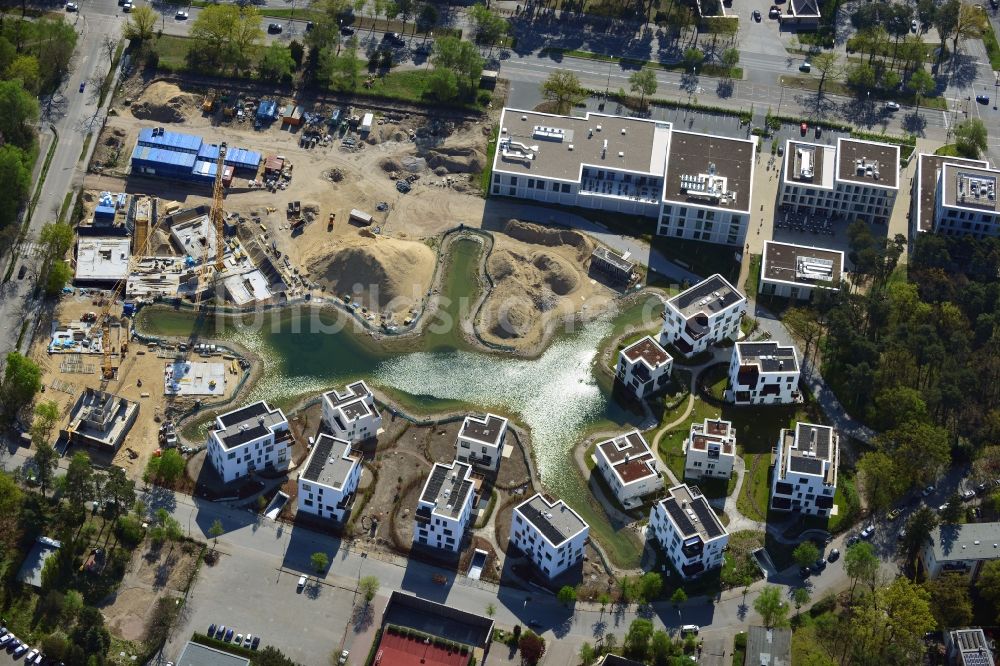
[305,236,435,314]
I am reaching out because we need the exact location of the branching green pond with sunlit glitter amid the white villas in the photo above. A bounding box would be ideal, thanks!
[139,240,662,566]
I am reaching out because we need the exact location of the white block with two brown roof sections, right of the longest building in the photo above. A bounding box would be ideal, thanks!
[778,137,899,224]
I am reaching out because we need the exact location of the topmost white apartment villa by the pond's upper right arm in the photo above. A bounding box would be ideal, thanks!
[660,273,747,356]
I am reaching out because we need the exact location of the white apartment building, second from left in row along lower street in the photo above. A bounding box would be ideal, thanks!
[298,433,361,522]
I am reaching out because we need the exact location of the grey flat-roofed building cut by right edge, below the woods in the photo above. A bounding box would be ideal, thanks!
[920,523,1000,582]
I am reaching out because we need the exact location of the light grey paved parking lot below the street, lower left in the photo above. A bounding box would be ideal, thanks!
[164,550,368,664]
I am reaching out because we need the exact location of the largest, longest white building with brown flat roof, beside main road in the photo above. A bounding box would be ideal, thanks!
[490,108,757,247]
